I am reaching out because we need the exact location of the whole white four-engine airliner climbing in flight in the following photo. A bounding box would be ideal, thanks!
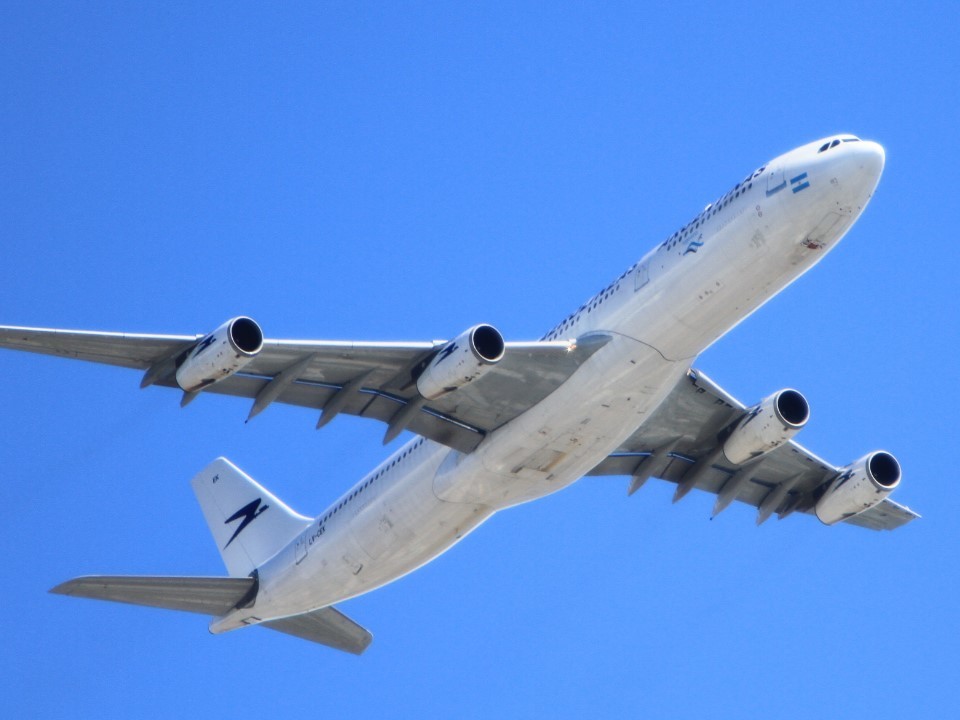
[0,134,919,654]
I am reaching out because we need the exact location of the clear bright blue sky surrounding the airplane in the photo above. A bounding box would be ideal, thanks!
[0,1,960,719]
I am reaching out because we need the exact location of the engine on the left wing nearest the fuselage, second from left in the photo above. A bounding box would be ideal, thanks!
[417,325,504,400]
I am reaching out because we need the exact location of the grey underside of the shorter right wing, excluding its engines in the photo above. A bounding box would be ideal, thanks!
[588,370,919,530]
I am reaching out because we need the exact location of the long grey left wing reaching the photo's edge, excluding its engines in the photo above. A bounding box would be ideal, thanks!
[0,326,609,452]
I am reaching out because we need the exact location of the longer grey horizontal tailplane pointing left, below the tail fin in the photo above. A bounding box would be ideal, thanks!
[50,575,256,615]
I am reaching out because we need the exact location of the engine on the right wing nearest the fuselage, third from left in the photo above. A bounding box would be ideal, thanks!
[723,389,810,465]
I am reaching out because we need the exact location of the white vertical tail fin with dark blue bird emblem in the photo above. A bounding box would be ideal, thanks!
[191,458,312,577]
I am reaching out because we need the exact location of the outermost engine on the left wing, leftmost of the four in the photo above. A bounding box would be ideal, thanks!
[177,317,263,392]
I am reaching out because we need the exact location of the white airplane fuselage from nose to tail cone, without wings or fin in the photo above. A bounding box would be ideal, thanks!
[211,136,884,632]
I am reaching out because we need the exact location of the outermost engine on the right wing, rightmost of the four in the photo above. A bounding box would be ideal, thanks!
[817,450,900,525]
